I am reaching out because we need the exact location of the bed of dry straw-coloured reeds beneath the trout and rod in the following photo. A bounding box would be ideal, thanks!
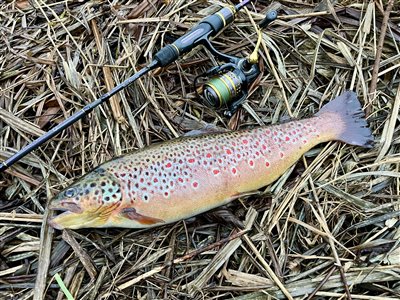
[0,0,400,299]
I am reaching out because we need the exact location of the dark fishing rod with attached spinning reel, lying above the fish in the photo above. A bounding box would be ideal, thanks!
[0,0,276,172]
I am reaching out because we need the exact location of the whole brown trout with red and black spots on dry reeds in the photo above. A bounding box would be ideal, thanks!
[49,91,373,230]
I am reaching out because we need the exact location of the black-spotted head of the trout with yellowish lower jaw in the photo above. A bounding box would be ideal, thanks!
[49,167,122,229]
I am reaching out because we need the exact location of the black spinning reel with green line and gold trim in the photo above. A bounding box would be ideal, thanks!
[194,10,277,117]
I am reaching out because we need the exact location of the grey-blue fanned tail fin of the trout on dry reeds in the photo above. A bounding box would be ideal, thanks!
[316,91,374,148]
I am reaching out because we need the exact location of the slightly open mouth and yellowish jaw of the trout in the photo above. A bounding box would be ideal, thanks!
[48,202,105,230]
